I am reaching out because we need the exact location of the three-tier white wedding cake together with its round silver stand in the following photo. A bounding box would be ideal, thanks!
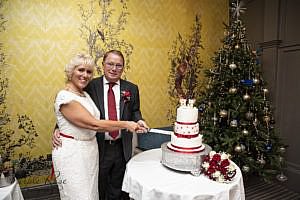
[161,99,211,176]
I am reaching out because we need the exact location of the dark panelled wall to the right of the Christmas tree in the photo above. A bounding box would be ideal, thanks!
[242,0,300,192]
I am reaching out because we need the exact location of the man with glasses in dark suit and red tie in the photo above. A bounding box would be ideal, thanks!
[53,50,149,200]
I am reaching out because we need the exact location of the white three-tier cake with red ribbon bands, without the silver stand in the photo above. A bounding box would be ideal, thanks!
[167,99,205,153]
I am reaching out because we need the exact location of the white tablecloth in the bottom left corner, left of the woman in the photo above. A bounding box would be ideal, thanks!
[0,179,24,200]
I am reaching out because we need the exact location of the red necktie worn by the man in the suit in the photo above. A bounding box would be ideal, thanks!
[107,83,119,139]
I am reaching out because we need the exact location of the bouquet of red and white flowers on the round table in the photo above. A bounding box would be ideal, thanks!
[201,151,236,183]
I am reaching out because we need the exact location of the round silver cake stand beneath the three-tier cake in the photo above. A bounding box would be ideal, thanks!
[161,142,211,176]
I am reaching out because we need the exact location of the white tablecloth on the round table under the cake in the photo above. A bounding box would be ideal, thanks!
[122,148,245,200]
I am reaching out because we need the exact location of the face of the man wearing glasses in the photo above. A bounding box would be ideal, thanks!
[102,53,124,82]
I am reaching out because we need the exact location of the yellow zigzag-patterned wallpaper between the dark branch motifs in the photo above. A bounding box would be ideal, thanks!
[0,0,228,158]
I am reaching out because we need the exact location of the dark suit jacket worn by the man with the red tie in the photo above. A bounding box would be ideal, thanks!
[85,76,142,163]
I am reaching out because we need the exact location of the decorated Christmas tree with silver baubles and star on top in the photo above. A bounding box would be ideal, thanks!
[198,2,285,180]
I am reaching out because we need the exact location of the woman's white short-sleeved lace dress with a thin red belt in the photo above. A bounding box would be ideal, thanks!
[52,90,100,200]
